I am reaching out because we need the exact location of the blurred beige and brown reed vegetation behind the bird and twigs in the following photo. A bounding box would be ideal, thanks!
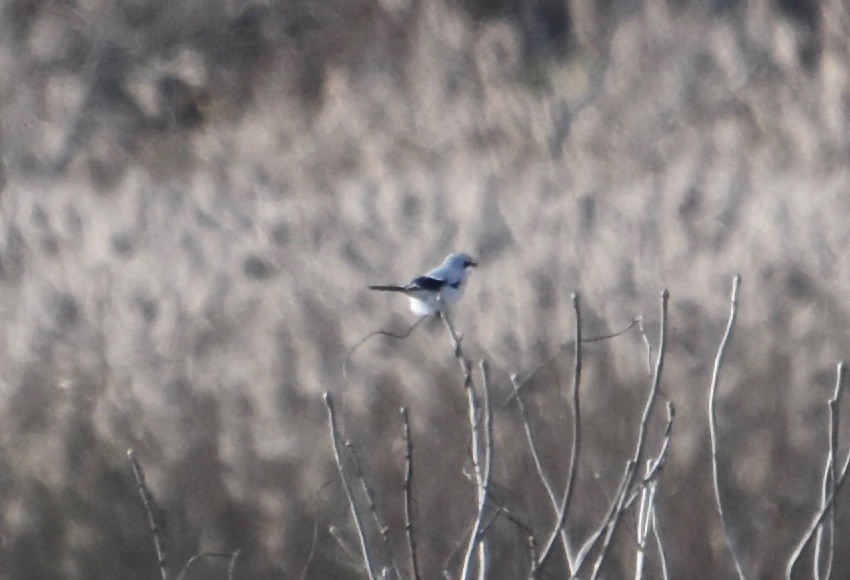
[0,0,850,579]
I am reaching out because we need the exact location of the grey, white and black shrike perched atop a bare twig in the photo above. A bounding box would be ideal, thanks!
[369,253,478,316]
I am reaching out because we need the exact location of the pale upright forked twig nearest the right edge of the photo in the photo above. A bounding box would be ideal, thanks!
[813,361,846,580]
